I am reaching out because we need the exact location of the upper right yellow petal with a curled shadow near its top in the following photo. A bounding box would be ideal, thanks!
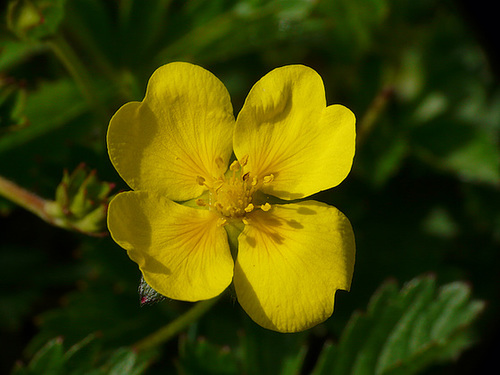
[234,65,355,199]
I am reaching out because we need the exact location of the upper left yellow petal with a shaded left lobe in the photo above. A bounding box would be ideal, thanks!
[107,62,234,201]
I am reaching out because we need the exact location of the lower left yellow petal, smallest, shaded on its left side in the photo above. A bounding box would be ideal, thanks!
[108,191,233,301]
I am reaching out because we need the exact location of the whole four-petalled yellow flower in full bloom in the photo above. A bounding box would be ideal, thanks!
[107,62,355,332]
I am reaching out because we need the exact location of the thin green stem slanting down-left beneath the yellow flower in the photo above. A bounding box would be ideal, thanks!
[133,297,219,351]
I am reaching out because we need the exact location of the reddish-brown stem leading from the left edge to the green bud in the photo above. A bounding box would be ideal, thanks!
[0,176,54,224]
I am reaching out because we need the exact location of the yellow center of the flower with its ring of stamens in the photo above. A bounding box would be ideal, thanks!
[196,156,274,225]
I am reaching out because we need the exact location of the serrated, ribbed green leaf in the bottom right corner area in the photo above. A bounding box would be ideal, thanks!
[313,276,484,375]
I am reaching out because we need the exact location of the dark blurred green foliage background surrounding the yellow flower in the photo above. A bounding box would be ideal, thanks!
[0,0,500,375]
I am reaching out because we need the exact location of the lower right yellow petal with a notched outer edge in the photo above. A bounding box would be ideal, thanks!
[234,201,355,332]
